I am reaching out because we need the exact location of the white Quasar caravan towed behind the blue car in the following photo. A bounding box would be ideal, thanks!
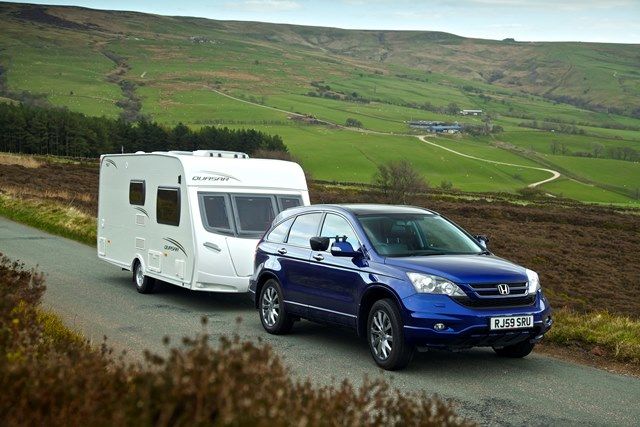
[98,150,309,293]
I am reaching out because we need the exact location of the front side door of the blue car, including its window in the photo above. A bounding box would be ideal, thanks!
[305,213,365,326]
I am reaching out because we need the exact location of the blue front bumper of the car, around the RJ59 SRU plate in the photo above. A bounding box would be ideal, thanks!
[402,291,553,349]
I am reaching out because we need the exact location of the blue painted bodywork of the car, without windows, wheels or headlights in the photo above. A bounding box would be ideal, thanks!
[249,205,552,348]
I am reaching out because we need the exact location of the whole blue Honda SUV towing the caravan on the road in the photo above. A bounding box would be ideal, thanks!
[249,205,552,370]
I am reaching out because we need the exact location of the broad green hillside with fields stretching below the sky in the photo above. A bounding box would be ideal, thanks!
[0,3,640,204]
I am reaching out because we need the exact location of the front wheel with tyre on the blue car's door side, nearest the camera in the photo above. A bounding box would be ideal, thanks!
[367,299,415,371]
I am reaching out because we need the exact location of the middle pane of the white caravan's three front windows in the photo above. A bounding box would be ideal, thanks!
[233,196,276,235]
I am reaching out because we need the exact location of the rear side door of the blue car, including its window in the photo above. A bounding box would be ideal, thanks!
[276,212,323,314]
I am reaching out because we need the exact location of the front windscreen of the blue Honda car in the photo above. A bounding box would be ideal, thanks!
[358,213,483,257]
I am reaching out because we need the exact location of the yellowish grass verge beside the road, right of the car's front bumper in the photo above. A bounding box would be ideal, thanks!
[545,309,640,365]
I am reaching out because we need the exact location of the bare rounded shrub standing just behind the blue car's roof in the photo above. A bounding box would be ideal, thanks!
[373,160,428,204]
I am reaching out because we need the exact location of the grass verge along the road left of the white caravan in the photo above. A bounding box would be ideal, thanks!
[0,194,96,245]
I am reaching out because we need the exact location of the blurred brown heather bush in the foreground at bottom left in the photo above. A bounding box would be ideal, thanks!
[0,254,469,426]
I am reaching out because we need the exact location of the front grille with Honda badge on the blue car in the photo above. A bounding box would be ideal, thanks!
[454,282,535,308]
